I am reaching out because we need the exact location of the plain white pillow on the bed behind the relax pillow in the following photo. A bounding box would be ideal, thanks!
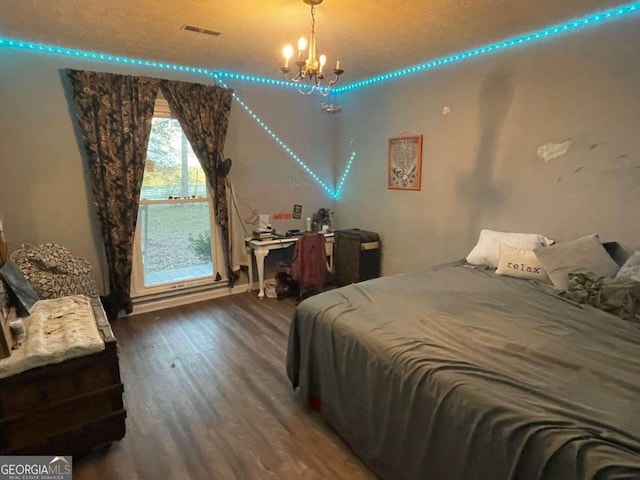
[467,229,553,268]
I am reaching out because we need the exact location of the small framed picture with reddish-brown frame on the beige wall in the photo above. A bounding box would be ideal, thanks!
[387,135,422,190]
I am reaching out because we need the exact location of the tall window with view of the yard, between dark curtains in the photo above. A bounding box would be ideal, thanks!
[131,99,223,297]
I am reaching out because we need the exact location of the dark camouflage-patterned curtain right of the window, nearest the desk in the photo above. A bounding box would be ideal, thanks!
[160,80,239,286]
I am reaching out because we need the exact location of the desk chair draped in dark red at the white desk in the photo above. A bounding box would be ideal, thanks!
[276,233,329,300]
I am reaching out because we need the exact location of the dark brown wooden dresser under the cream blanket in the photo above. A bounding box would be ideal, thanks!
[0,299,126,455]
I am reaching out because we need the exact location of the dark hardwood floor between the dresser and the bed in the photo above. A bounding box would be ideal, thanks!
[74,292,375,480]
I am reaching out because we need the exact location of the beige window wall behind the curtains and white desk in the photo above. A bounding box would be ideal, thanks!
[0,48,335,290]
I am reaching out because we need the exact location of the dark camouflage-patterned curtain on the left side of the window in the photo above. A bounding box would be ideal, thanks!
[67,70,159,319]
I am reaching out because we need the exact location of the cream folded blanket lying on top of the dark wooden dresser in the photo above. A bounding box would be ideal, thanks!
[0,295,105,378]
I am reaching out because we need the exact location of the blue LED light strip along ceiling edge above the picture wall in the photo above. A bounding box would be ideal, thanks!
[332,2,640,93]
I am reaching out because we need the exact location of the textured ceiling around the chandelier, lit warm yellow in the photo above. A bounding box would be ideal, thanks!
[0,0,625,82]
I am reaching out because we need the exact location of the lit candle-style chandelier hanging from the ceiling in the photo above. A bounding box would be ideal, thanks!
[280,0,344,96]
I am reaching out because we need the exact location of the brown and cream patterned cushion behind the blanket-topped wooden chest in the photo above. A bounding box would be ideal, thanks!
[11,243,98,299]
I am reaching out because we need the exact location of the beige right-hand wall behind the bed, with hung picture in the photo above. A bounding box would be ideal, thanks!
[337,17,640,274]
